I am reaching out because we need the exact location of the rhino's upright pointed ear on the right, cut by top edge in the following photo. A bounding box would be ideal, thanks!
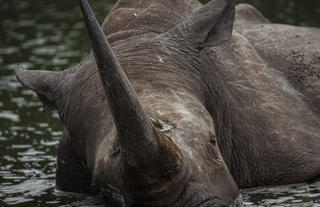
[165,0,235,48]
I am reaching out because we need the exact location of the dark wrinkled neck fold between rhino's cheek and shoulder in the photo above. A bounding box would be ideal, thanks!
[200,47,260,185]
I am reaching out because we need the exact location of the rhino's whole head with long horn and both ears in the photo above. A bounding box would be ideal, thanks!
[16,0,238,207]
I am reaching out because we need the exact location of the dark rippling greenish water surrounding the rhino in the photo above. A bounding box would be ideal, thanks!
[0,0,320,207]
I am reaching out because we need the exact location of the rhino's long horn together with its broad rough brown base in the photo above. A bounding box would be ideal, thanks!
[79,0,189,205]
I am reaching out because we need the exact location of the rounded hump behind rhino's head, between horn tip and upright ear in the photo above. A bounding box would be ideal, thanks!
[102,0,201,35]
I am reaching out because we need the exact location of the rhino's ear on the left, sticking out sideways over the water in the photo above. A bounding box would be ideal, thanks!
[15,68,63,111]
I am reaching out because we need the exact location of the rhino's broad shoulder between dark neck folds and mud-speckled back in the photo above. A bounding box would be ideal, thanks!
[204,31,320,187]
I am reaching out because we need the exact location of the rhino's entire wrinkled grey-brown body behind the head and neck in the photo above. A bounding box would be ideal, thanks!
[214,5,320,188]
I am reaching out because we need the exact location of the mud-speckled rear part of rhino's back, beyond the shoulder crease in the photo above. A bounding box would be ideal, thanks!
[235,24,320,117]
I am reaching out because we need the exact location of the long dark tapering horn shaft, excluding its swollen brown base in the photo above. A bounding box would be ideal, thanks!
[79,0,158,164]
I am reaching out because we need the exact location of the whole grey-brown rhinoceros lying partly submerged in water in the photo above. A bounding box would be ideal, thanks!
[15,0,320,207]
